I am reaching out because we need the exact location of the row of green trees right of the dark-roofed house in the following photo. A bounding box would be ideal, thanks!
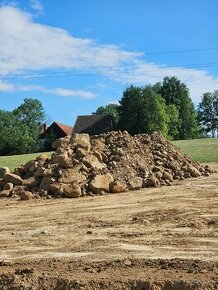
[95,77,218,140]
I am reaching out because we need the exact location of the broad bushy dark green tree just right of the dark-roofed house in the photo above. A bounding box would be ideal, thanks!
[119,86,168,135]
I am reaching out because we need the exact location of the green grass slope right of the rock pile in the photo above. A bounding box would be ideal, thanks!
[173,138,218,163]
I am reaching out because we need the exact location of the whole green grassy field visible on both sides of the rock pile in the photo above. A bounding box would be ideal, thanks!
[0,138,218,171]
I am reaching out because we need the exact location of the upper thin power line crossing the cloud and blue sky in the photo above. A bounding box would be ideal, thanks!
[0,47,218,63]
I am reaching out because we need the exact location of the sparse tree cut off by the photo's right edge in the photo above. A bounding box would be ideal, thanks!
[198,90,218,137]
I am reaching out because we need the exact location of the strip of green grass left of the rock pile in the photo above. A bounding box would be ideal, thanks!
[0,152,52,171]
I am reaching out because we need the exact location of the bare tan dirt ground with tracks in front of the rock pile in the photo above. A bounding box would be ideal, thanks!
[0,164,218,290]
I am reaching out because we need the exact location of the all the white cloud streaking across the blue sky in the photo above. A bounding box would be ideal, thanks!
[0,5,218,102]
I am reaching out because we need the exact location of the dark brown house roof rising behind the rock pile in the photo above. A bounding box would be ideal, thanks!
[73,115,113,135]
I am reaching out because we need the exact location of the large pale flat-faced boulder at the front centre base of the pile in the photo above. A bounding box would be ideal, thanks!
[89,173,114,194]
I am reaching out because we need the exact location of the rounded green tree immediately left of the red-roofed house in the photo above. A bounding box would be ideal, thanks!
[12,99,45,153]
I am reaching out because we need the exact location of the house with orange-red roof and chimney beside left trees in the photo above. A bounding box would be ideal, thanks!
[39,122,73,150]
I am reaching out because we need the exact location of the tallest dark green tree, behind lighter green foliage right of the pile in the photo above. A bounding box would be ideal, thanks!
[160,77,199,139]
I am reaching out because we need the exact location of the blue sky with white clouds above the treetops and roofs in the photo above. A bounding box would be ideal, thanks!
[0,0,218,125]
